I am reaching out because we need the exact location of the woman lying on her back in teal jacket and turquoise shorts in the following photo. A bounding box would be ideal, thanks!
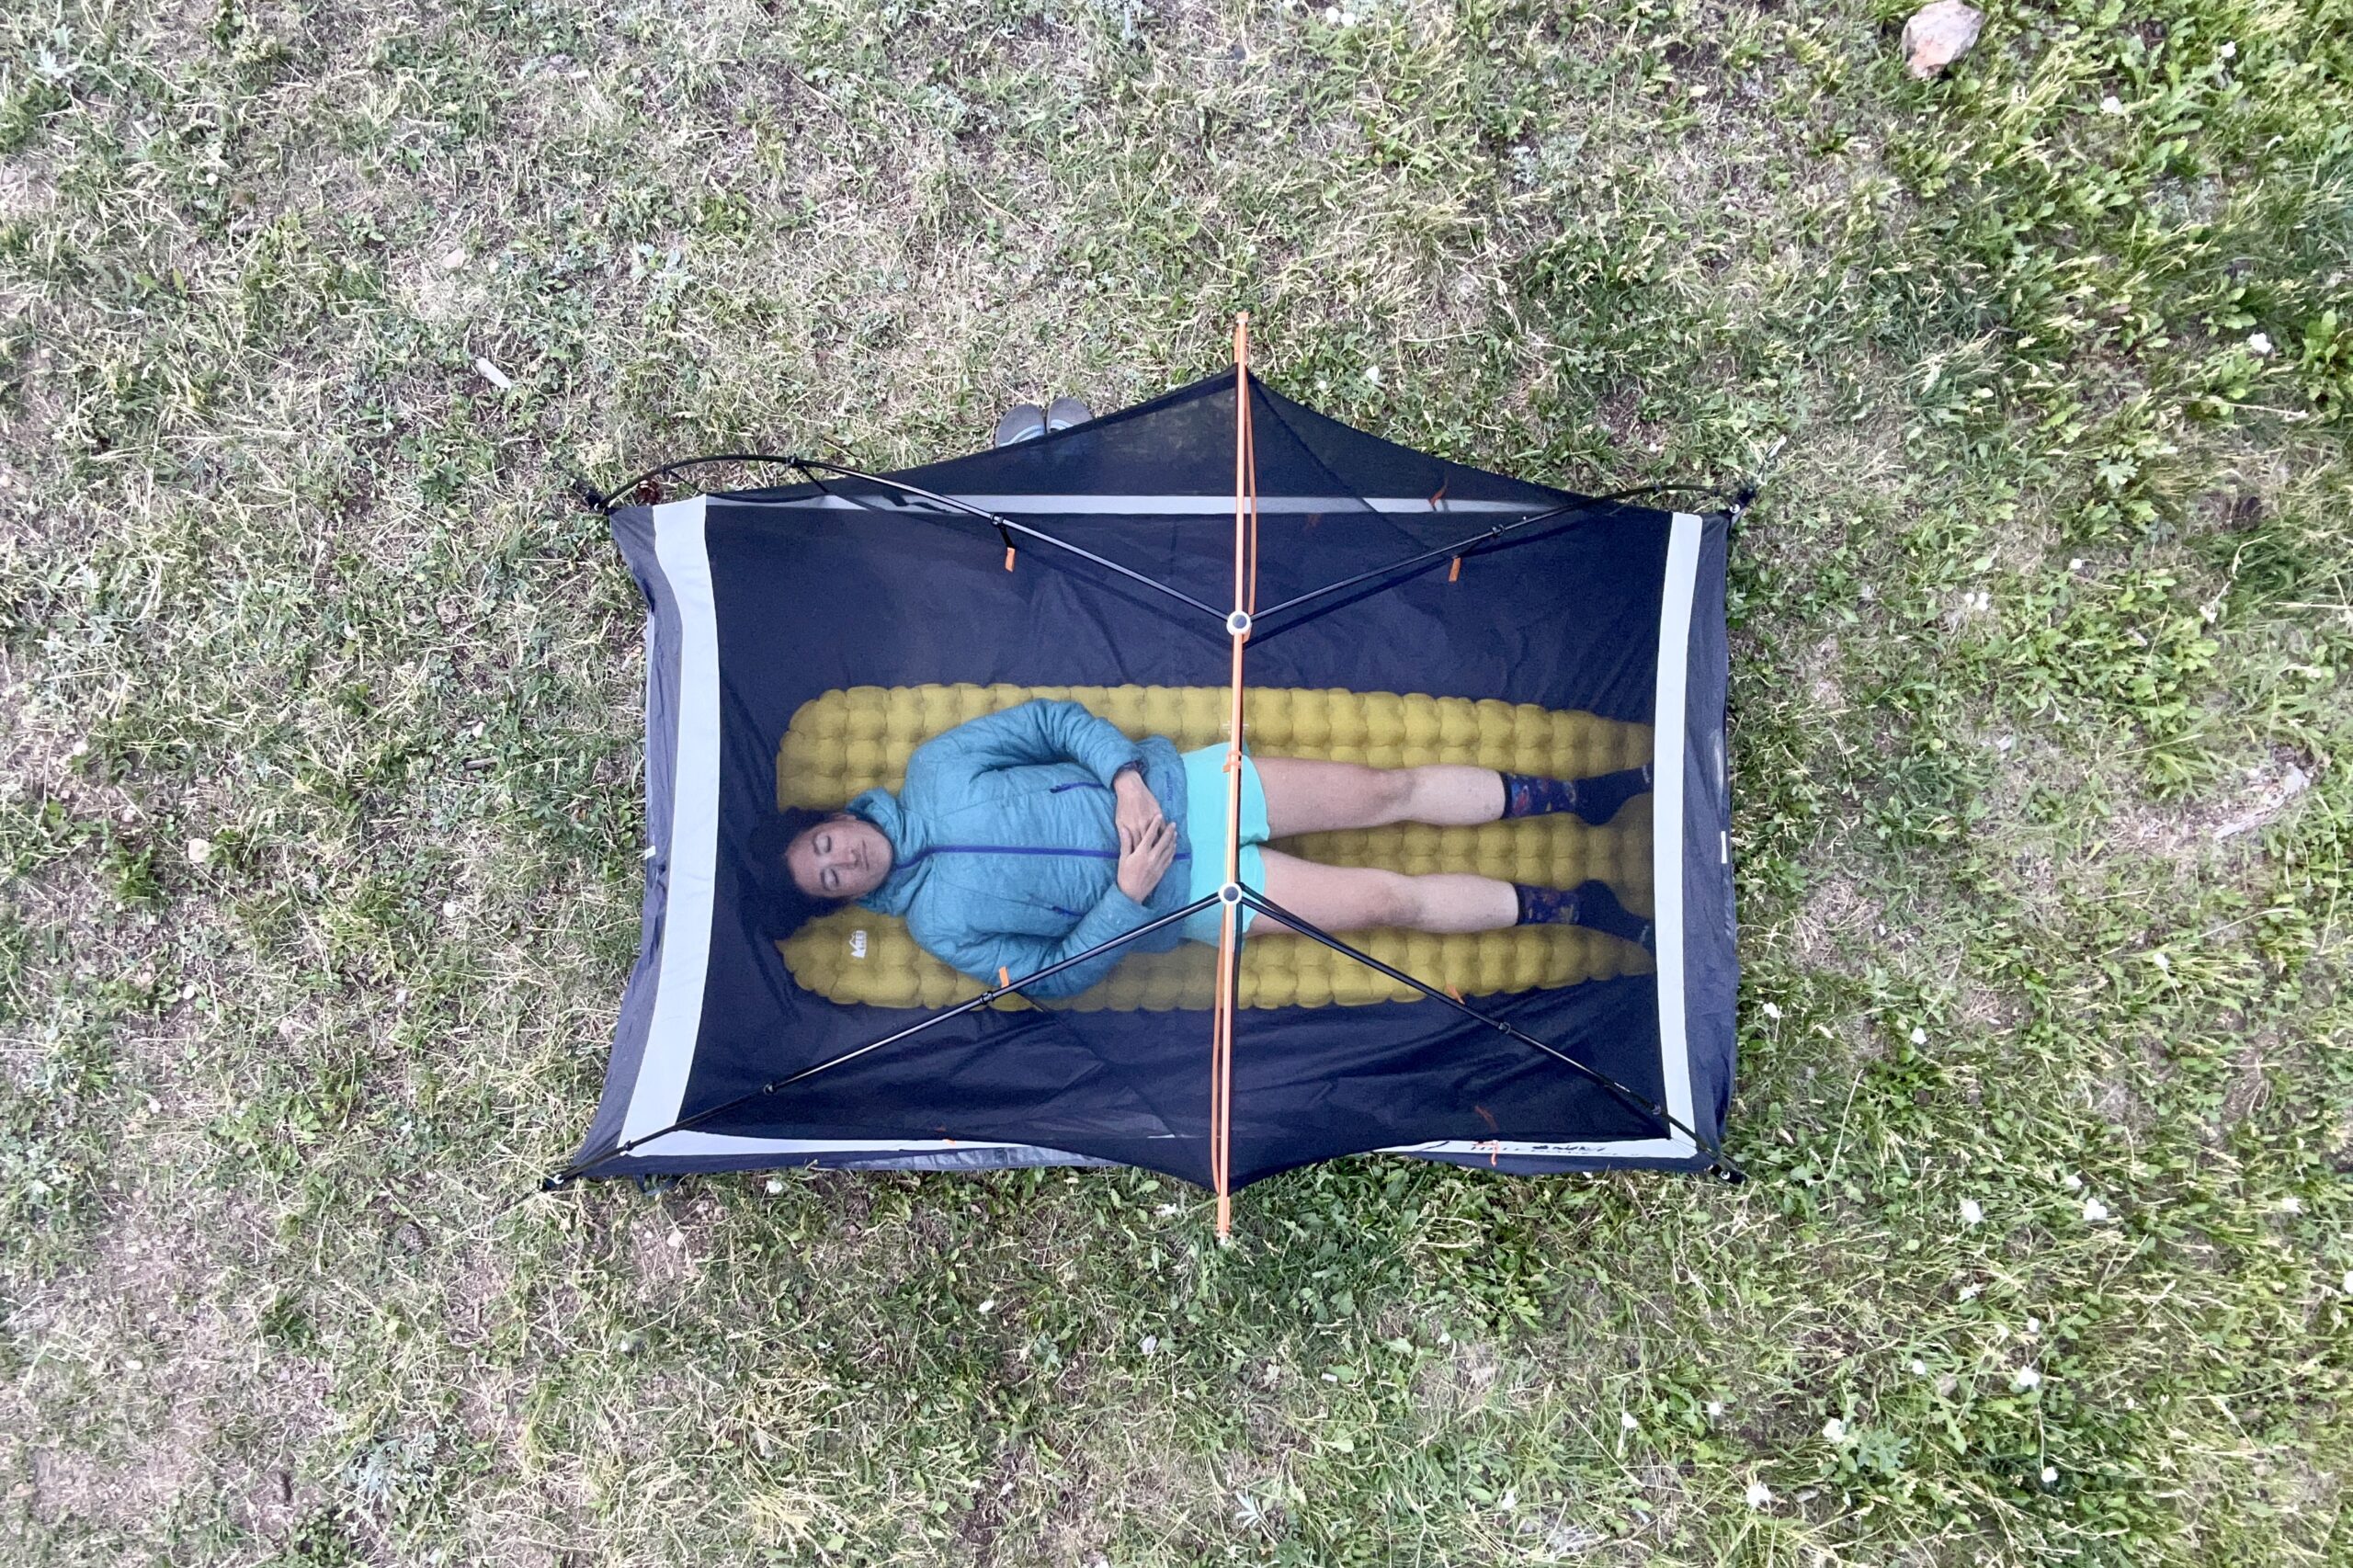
[777,699,1652,998]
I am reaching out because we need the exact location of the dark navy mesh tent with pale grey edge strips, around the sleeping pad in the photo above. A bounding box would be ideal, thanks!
[574,377,1736,1187]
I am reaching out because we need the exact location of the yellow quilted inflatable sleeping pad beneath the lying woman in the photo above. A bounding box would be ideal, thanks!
[777,685,1652,1010]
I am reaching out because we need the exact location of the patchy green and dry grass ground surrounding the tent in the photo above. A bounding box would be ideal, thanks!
[0,0,2353,1568]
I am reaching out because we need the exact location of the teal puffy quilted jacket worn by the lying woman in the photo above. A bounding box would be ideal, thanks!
[849,699,1193,998]
